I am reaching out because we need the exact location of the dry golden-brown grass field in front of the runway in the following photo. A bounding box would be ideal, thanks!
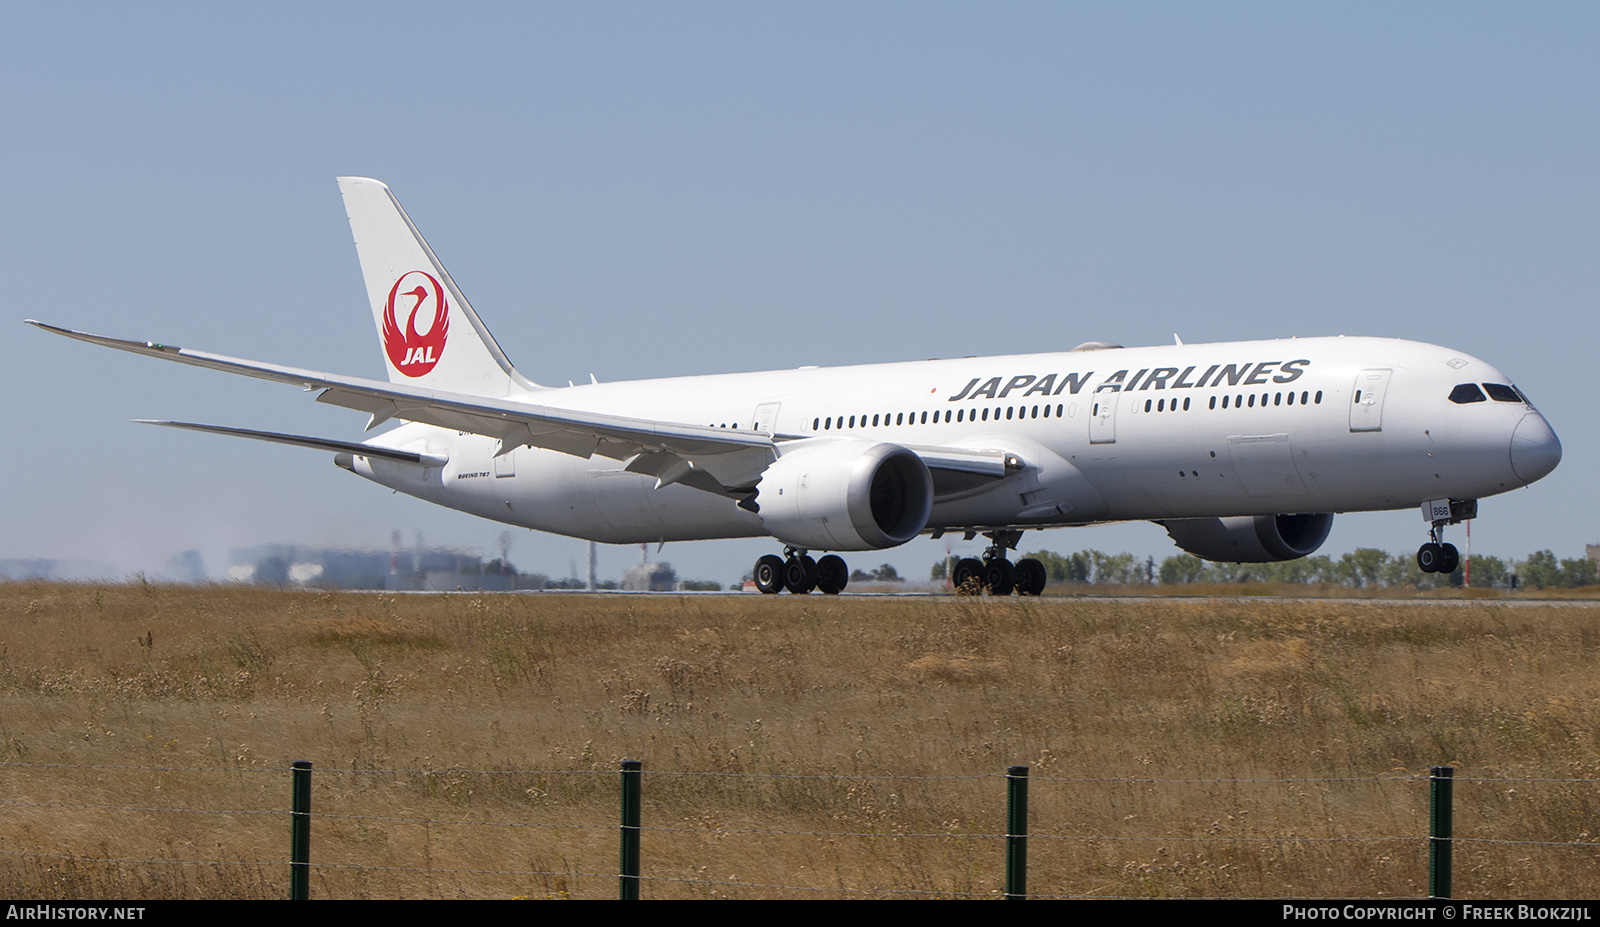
[0,583,1600,898]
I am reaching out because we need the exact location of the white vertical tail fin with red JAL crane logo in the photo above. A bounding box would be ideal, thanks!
[339,178,539,397]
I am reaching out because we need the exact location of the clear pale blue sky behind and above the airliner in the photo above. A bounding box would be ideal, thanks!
[0,2,1600,581]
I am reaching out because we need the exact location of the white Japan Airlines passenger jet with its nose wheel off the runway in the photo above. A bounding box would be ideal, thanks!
[27,178,1562,596]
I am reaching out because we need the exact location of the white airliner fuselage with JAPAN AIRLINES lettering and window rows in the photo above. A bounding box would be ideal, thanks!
[354,338,1560,543]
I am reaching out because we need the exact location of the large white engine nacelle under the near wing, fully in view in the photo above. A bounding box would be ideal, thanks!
[755,440,933,551]
